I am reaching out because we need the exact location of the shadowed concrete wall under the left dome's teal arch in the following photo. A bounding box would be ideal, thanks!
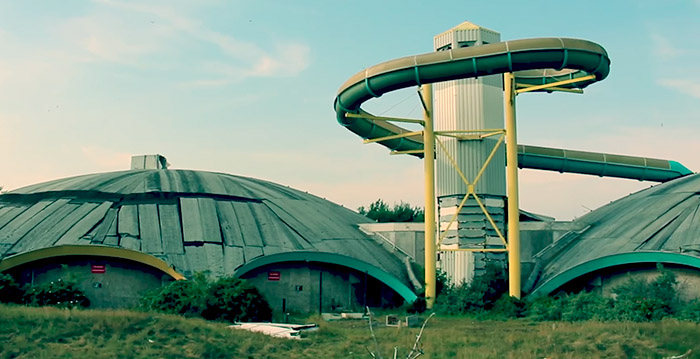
[243,262,403,313]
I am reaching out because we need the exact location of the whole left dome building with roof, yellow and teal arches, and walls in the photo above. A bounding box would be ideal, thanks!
[0,156,416,311]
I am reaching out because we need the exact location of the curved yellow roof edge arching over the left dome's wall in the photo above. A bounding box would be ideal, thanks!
[0,245,185,280]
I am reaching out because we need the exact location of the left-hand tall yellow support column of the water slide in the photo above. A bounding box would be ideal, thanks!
[421,84,437,309]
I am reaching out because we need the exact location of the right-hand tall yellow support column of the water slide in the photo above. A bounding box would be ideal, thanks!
[503,73,520,298]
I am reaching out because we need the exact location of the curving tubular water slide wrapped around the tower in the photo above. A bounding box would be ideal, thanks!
[334,38,692,182]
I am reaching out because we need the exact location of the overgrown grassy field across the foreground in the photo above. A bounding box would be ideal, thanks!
[0,305,700,359]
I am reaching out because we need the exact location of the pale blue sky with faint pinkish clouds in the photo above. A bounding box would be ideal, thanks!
[0,0,700,220]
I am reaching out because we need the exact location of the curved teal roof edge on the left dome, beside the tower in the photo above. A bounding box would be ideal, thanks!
[234,251,418,303]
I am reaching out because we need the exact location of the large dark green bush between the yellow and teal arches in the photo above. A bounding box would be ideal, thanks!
[140,273,272,322]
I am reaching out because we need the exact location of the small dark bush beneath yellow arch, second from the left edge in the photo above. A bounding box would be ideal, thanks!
[23,278,90,308]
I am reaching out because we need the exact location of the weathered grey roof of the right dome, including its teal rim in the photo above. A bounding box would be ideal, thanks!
[528,174,700,293]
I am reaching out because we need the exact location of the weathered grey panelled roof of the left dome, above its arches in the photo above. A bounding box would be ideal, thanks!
[0,169,416,297]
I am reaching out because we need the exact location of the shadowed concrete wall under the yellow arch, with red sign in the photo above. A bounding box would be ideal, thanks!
[10,257,173,308]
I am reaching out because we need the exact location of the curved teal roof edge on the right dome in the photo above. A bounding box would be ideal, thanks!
[530,251,700,297]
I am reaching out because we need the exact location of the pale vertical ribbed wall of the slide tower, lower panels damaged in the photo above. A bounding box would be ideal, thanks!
[433,22,506,283]
